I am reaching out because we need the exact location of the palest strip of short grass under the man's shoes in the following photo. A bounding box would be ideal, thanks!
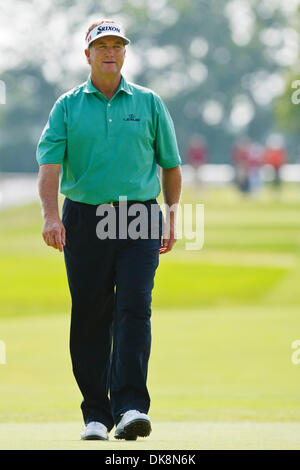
[0,421,300,455]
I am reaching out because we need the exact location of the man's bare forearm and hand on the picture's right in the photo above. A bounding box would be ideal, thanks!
[159,165,182,254]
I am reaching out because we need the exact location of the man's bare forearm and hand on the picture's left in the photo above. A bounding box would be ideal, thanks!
[38,163,66,251]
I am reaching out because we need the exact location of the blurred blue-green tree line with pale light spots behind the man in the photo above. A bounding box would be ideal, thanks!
[0,0,300,171]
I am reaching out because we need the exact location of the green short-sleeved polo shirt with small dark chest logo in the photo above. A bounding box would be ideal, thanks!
[36,76,181,204]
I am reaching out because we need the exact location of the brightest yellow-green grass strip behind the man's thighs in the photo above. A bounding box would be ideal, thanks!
[0,253,289,318]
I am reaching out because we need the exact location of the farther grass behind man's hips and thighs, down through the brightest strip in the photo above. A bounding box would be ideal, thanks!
[0,185,300,318]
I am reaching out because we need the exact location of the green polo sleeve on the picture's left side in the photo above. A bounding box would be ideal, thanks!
[36,99,67,165]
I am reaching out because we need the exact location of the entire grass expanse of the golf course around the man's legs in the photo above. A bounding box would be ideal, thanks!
[0,186,300,449]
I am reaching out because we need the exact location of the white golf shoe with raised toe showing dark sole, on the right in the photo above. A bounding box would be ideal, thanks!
[115,410,151,441]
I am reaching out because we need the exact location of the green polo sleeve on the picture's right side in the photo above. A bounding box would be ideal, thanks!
[154,95,181,168]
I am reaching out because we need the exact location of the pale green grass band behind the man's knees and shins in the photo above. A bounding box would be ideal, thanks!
[0,307,300,422]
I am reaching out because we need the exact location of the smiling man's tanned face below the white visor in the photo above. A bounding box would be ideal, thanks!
[85,36,126,76]
